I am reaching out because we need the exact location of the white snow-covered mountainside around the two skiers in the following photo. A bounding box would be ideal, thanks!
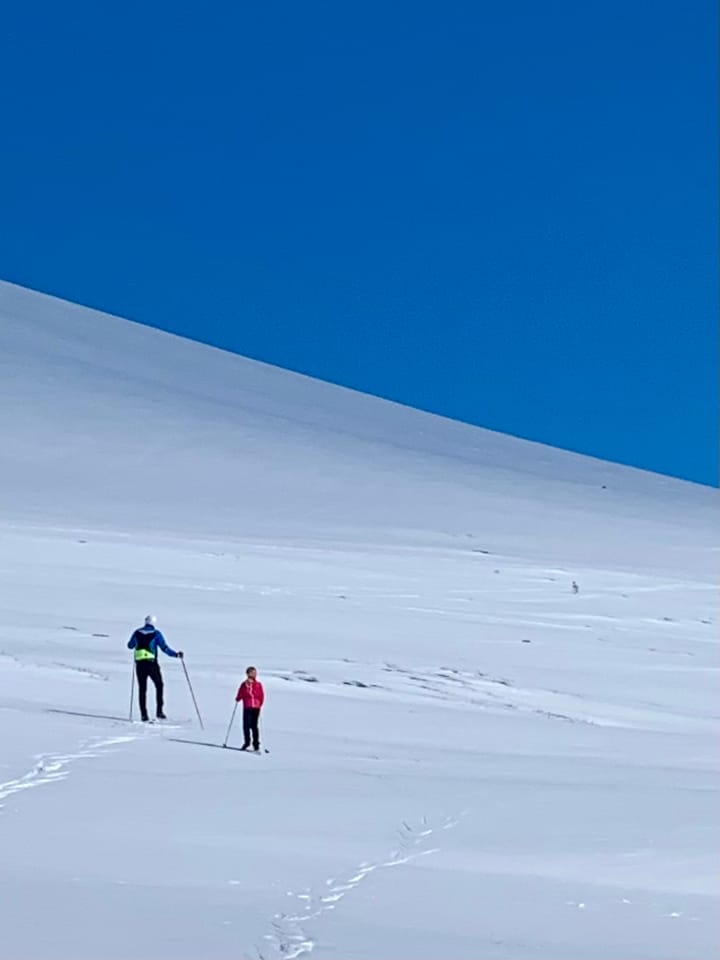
[0,284,720,960]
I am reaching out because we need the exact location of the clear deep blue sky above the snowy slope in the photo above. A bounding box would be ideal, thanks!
[0,0,718,484]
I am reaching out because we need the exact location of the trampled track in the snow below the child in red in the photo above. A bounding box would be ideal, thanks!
[255,812,465,960]
